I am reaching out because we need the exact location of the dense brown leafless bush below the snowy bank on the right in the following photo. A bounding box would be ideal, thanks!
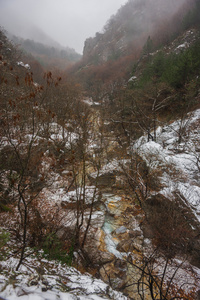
[144,194,195,257]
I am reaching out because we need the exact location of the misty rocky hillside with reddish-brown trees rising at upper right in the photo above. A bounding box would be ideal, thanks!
[71,0,199,101]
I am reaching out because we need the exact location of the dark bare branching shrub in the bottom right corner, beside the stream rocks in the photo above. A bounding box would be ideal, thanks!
[125,249,195,300]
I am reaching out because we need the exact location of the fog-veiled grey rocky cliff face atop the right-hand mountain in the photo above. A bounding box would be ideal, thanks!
[83,0,195,64]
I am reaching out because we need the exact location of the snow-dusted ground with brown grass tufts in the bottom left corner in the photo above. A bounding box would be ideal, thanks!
[0,253,127,300]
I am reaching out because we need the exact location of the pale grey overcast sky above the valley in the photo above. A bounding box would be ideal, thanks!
[0,0,128,53]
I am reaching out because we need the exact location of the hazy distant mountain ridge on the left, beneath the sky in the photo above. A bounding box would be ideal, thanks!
[2,16,81,69]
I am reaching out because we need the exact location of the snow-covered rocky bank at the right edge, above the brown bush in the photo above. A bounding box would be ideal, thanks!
[133,109,200,220]
